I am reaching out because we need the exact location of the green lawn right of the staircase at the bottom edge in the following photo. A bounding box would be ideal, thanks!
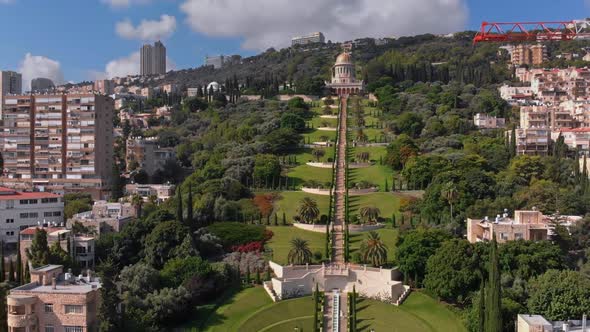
[357,292,466,332]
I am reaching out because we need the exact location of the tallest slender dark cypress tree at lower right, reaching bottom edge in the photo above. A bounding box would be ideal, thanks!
[484,233,502,332]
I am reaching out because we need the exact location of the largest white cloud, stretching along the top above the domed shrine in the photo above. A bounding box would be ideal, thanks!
[180,0,468,50]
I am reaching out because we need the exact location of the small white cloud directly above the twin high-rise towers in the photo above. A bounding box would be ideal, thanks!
[115,15,176,40]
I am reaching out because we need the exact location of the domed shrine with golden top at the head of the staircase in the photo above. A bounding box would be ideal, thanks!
[326,52,364,96]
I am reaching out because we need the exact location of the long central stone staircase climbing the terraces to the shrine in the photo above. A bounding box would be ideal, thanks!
[323,96,348,332]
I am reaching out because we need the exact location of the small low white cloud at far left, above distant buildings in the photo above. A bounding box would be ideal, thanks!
[19,53,64,90]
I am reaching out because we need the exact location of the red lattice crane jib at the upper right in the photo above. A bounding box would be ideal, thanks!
[473,20,590,44]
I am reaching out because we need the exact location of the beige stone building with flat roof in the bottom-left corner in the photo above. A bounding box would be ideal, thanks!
[6,265,101,332]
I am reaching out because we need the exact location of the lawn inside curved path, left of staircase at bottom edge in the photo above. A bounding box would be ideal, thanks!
[239,290,313,332]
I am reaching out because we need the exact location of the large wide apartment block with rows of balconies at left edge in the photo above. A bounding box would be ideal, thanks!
[0,94,114,198]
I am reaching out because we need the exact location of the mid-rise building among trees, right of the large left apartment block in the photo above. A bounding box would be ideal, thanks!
[125,137,176,176]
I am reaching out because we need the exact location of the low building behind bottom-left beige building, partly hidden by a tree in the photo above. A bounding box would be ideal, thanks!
[20,223,95,268]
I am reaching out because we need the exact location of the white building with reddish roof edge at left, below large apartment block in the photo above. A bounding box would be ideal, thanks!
[0,187,64,244]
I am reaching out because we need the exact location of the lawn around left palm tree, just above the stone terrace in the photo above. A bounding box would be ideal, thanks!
[267,226,326,264]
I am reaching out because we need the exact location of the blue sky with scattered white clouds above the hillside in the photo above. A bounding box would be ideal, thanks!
[0,0,590,85]
